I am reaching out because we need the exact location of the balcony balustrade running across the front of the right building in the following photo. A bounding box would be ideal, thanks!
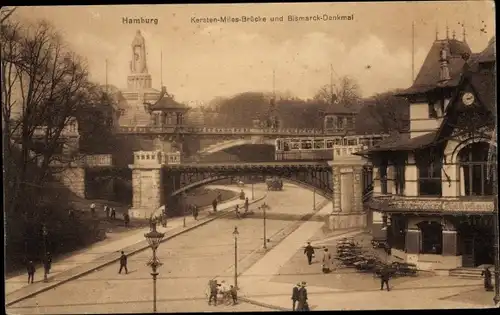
[369,195,494,213]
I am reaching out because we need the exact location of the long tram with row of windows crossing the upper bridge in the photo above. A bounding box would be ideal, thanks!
[275,135,386,160]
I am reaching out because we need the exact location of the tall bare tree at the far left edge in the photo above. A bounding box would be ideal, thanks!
[1,22,110,221]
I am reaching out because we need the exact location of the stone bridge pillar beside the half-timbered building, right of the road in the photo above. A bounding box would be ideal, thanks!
[328,155,368,230]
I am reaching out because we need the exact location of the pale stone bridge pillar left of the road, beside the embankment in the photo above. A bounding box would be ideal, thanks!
[129,150,166,218]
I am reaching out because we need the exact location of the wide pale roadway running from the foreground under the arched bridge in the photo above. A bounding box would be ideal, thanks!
[5,185,320,314]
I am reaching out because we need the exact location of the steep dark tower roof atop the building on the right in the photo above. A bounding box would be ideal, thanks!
[399,39,472,95]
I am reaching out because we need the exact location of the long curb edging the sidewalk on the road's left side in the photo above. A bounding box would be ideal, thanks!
[5,194,267,307]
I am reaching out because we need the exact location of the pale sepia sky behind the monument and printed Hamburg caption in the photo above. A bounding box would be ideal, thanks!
[13,1,495,103]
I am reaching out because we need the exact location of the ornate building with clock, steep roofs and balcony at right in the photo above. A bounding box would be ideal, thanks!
[358,36,497,272]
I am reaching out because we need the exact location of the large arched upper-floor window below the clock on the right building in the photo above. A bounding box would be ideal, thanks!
[458,142,497,196]
